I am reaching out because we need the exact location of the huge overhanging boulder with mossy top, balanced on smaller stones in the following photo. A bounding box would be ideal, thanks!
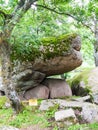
[12,34,82,76]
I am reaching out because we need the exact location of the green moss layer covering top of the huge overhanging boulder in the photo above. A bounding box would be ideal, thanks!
[11,33,77,61]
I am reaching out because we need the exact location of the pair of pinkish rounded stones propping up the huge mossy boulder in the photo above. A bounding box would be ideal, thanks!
[20,78,72,99]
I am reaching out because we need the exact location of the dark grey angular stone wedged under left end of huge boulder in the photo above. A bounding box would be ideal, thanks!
[15,70,45,91]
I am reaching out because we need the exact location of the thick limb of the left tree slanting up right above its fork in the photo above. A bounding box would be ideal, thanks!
[5,0,38,37]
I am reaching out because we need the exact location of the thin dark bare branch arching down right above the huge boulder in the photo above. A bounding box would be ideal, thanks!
[34,4,94,33]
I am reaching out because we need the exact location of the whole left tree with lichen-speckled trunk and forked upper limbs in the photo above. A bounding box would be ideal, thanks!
[0,0,38,112]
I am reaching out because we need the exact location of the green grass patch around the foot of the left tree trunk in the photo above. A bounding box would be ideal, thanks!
[0,107,49,128]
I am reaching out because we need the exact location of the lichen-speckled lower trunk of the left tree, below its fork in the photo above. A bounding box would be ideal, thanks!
[0,42,21,112]
